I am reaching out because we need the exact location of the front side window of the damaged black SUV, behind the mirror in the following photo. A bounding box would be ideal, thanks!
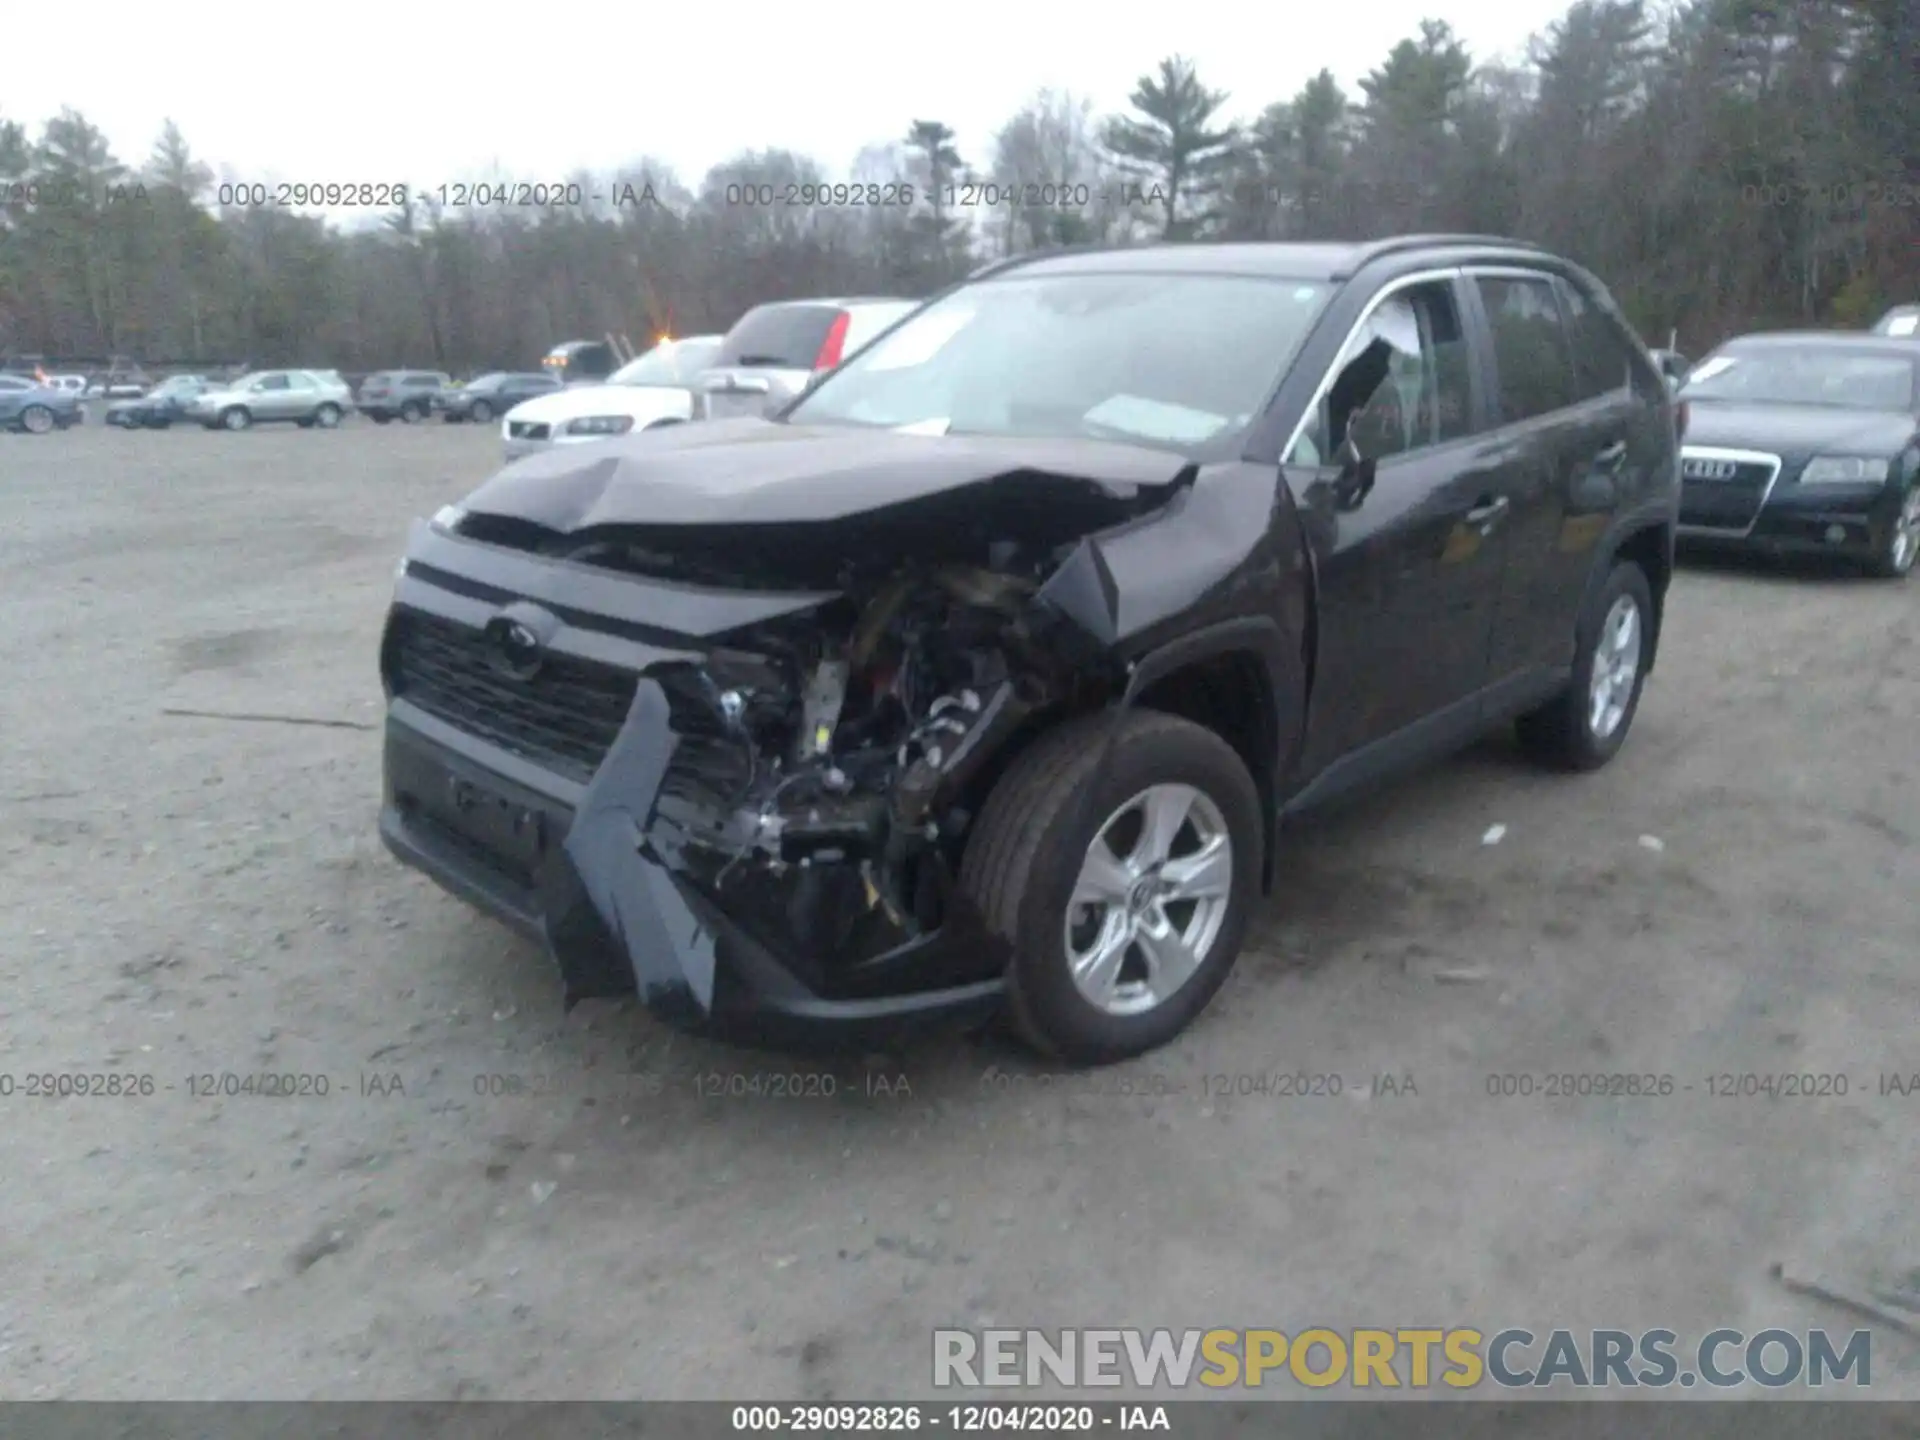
[1284,280,1473,467]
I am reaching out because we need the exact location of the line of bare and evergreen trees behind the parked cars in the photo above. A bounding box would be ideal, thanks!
[0,0,1920,371]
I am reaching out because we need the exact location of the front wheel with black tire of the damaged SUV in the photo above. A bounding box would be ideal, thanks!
[960,710,1265,1064]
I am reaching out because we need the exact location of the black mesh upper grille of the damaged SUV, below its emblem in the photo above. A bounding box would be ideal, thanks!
[388,611,636,783]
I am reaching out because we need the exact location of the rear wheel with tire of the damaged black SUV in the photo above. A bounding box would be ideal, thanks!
[1515,561,1653,770]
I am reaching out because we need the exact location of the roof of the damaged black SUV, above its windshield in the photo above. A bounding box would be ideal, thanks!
[970,234,1565,282]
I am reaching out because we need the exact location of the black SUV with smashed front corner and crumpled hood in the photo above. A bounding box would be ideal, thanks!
[380,236,1678,1064]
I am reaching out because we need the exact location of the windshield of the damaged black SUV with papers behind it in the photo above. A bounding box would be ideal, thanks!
[787,275,1329,453]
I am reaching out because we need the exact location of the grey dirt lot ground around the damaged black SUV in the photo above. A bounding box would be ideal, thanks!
[0,424,1920,1400]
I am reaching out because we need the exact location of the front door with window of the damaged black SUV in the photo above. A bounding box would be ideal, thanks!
[1284,275,1509,774]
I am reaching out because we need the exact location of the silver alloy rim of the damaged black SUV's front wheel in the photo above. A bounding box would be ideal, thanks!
[1066,783,1233,1016]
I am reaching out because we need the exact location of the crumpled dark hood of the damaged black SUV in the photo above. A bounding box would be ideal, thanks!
[465,416,1190,534]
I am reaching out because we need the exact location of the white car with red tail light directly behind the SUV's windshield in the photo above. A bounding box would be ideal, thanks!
[695,300,920,420]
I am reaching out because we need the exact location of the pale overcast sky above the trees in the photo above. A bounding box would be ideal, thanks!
[15,0,1565,188]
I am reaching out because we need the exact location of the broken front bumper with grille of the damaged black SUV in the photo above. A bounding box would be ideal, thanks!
[380,526,1006,1046]
